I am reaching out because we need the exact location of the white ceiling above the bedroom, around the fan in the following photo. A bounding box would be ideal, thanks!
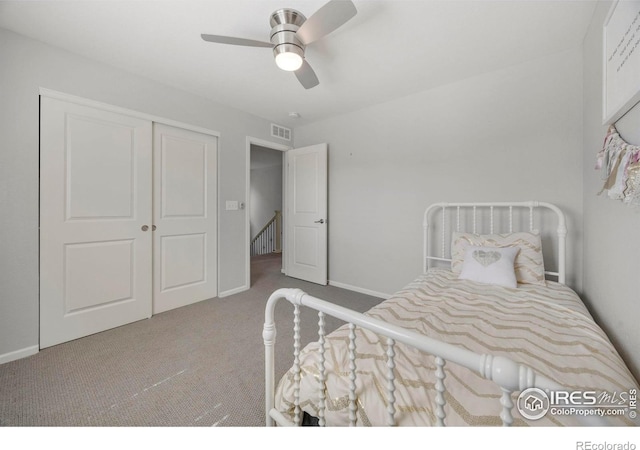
[0,0,595,127]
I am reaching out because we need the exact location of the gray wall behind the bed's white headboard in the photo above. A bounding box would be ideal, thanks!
[295,48,582,294]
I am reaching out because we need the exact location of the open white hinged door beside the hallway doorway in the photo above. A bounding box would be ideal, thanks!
[284,144,327,285]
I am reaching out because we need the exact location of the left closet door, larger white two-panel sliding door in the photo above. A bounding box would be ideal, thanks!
[40,97,152,348]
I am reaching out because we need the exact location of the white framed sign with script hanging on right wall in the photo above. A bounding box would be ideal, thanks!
[602,0,640,125]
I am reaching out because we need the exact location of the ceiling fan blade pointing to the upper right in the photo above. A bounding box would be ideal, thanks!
[296,0,358,45]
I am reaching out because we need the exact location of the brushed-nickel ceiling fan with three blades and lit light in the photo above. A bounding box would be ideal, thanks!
[200,0,357,89]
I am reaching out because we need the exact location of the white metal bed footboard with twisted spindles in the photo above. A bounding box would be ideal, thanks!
[263,289,607,426]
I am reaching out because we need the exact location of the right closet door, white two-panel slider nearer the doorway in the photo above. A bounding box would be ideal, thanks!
[153,124,218,314]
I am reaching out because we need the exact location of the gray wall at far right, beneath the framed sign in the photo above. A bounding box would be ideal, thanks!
[583,2,640,379]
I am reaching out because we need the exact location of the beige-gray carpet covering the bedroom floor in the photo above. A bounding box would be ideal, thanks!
[0,255,380,427]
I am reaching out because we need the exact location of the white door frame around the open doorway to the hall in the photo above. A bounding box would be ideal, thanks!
[244,136,293,289]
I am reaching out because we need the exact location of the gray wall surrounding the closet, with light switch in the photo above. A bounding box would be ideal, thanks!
[0,29,280,359]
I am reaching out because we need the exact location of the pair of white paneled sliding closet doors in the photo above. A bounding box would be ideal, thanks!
[40,90,218,348]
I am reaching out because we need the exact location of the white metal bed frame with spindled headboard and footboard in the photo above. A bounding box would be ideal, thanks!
[263,201,607,426]
